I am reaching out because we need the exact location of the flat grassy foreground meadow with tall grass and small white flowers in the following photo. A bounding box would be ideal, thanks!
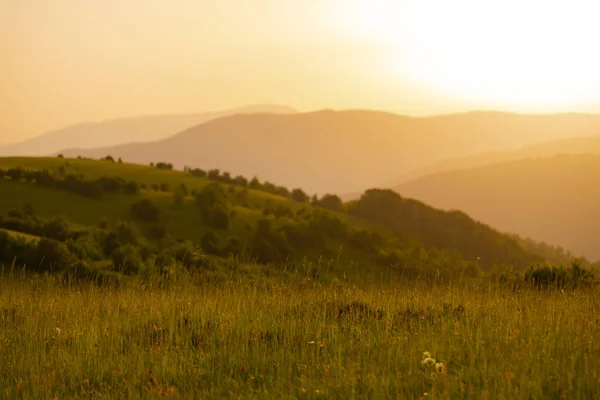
[0,265,600,399]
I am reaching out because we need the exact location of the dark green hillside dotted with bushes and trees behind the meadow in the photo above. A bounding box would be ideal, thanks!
[0,158,556,274]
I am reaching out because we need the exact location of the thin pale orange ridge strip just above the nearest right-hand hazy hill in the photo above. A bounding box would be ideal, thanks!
[396,135,600,184]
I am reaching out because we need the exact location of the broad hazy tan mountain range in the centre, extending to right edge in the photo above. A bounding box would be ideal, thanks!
[58,111,600,194]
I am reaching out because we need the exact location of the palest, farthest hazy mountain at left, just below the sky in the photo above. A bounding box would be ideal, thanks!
[0,105,296,156]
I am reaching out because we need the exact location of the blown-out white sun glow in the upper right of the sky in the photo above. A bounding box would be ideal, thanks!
[335,0,600,110]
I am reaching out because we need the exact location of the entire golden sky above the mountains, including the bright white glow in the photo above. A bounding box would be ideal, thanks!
[0,0,600,143]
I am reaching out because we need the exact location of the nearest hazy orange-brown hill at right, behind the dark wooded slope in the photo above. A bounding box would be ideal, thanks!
[395,154,600,260]
